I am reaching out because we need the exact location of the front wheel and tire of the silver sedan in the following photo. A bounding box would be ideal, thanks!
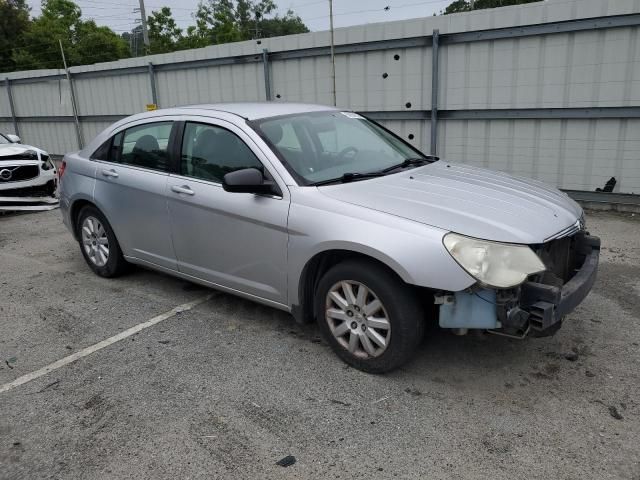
[315,259,426,373]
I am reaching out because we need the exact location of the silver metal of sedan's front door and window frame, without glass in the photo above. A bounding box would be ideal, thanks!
[167,116,290,304]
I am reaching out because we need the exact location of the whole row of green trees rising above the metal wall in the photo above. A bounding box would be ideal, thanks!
[0,0,309,72]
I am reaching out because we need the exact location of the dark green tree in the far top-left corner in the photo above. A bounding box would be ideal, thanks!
[0,0,29,72]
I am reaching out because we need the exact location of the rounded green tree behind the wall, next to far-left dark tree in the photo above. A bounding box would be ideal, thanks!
[12,0,129,70]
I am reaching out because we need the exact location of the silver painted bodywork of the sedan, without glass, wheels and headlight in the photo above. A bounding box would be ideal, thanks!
[61,103,582,310]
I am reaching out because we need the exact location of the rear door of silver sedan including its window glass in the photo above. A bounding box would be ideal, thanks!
[93,120,176,270]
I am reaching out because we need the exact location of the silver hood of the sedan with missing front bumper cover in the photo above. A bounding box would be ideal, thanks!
[319,161,582,244]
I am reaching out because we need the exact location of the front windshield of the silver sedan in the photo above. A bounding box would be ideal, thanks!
[253,111,429,185]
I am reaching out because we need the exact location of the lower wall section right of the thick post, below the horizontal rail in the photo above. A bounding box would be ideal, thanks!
[439,119,640,193]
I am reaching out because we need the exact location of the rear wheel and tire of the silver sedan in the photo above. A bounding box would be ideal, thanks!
[76,205,129,278]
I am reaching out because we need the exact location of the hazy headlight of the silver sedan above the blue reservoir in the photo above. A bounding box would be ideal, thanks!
[443,233,546,288]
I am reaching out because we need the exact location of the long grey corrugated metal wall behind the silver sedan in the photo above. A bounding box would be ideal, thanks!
[0,0,640,193]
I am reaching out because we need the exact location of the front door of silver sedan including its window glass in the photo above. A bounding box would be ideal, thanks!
[167,120,289,304]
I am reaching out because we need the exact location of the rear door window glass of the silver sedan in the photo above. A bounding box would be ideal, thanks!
[118,122,173,170]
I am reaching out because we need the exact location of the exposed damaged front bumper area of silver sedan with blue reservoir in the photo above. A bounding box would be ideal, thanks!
[436,232,600,337]
